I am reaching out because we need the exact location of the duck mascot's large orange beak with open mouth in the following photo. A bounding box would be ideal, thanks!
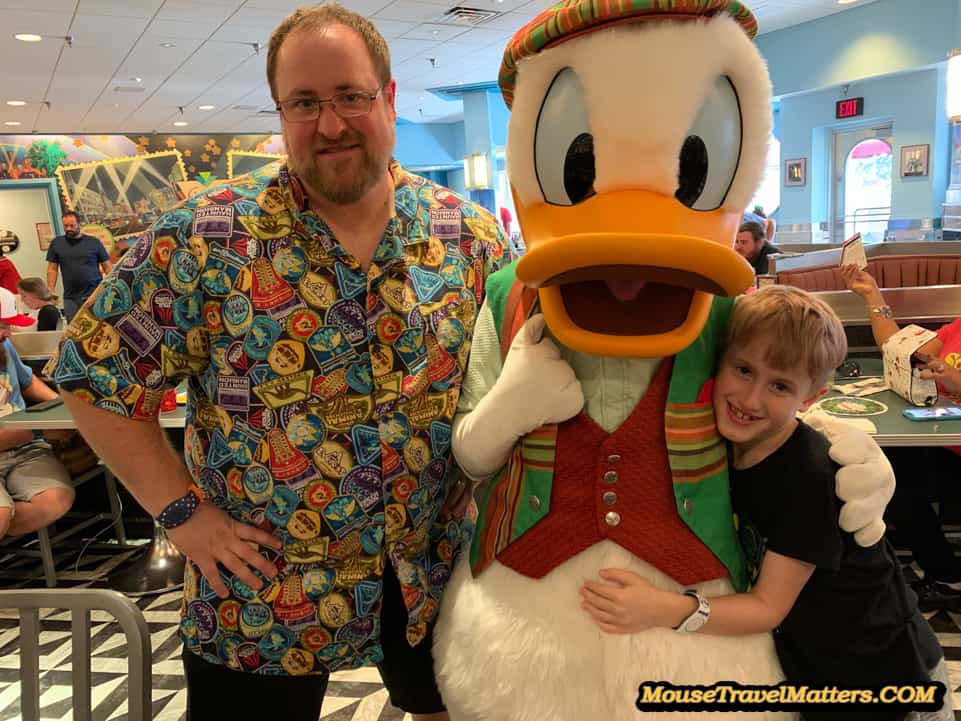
[515,190,754,357]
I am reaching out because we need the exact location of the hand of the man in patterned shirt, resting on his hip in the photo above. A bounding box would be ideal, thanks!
[167,503,281,598]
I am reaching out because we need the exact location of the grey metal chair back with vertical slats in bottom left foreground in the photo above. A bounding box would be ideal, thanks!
[0,589,152,721]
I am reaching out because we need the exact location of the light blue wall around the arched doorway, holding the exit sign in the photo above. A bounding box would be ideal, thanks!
[778,67,950,223]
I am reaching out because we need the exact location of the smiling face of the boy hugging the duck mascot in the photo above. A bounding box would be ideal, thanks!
[714,340,825,468]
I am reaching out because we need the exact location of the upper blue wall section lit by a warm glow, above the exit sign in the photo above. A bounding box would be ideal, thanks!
[748,0,961,95]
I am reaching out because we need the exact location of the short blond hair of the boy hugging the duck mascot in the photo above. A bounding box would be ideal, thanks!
[724,285,848,390]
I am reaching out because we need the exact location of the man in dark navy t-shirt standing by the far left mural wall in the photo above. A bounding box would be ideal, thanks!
[47,210,113,321]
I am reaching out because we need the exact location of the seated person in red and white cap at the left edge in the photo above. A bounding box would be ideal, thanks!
[0,288,74,538]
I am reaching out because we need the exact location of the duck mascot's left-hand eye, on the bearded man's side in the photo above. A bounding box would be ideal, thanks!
[534,68,595,205]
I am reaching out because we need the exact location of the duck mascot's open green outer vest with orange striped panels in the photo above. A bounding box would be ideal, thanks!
[471,263,747,592]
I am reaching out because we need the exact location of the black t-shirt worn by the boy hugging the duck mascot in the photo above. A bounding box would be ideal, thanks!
[731,422,942,721]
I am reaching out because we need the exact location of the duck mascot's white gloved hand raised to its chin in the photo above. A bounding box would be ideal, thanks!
[452,314,584,481]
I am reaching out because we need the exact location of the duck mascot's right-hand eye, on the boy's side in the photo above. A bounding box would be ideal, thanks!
[674,76,741,210]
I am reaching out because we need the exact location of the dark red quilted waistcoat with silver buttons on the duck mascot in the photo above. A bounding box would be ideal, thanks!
[497,359,727,585]
